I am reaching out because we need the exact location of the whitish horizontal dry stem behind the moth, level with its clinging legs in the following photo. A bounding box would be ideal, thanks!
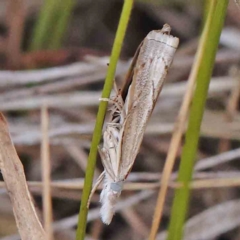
[0,74,234,111]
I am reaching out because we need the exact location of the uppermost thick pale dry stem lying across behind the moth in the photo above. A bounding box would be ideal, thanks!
[0,47,236,88]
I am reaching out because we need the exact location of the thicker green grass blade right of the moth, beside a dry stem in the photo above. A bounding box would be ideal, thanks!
[167,0,228,240]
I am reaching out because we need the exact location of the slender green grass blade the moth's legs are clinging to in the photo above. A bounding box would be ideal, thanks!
[76,0,133,240]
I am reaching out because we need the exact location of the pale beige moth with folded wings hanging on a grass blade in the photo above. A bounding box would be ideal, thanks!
[89,24,179,224]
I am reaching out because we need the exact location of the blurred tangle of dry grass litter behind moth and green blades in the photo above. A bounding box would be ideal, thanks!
[0,0,240,240]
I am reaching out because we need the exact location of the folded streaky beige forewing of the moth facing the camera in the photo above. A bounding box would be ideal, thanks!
[118,28,179,179]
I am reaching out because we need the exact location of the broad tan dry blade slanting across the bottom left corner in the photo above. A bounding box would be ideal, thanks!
[0,114,46,240]
